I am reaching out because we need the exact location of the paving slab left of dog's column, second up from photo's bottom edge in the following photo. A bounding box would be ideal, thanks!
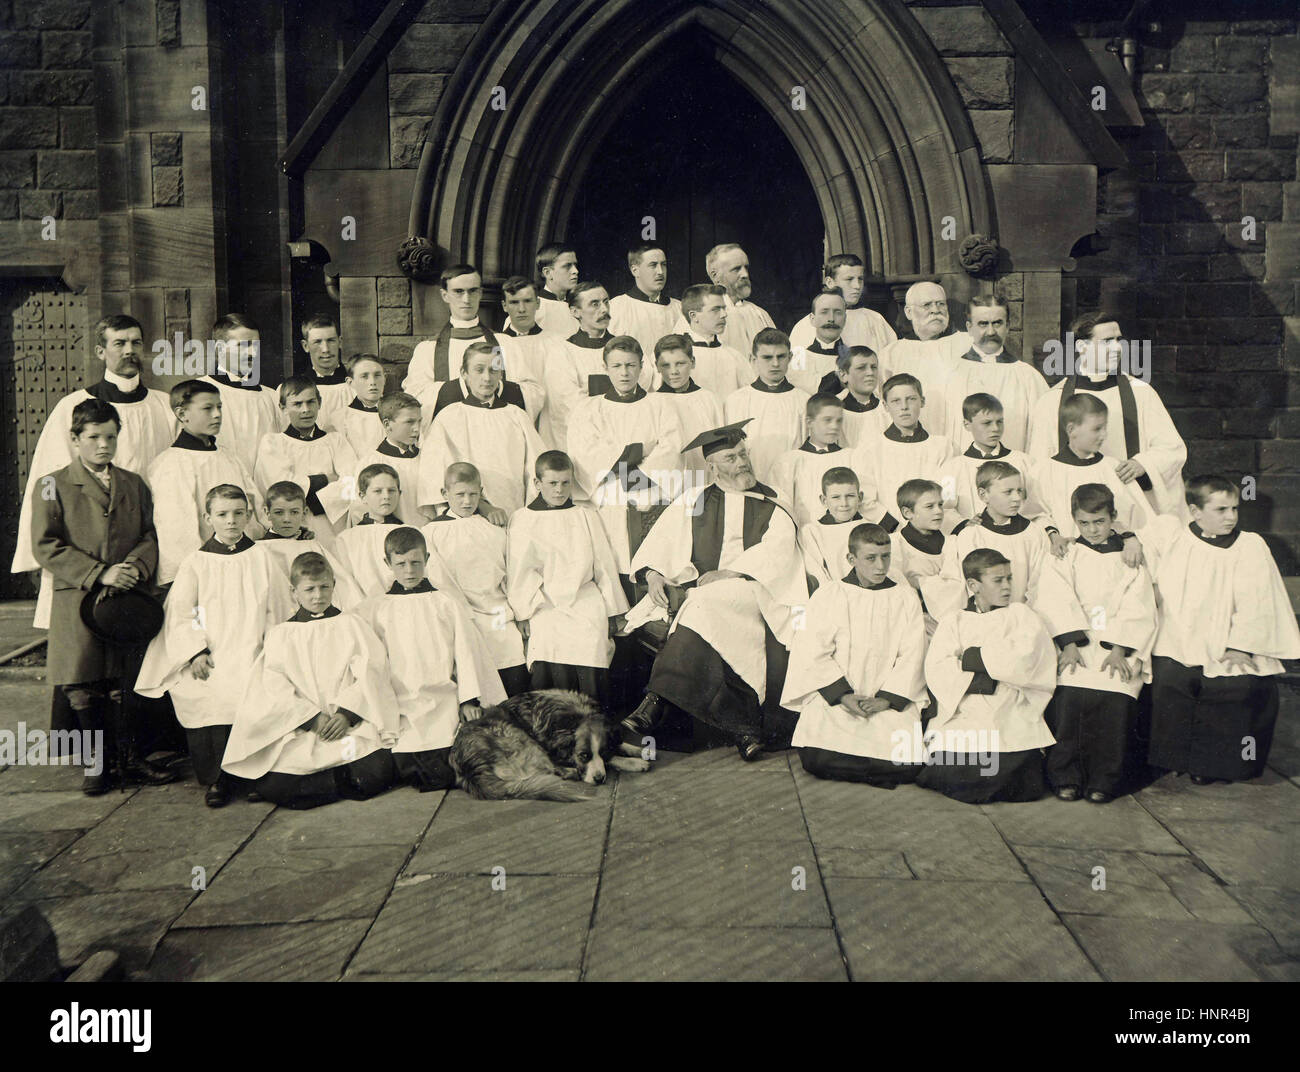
[176,845,411,928]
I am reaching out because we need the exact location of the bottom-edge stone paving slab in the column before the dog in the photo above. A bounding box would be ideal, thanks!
[350,874,597,972]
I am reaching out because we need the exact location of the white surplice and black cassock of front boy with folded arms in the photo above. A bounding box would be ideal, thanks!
[917,600,1057,804]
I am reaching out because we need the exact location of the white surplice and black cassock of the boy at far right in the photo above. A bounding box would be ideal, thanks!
[1141,516,1300,781]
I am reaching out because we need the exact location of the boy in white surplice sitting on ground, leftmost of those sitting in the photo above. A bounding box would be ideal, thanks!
[221,551,398,808]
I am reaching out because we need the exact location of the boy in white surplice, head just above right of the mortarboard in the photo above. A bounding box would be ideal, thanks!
[723,327,809,482]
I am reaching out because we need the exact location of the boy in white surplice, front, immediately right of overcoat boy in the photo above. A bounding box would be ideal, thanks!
[135,483,293,808]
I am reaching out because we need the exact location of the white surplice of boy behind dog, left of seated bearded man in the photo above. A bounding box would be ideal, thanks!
[506,498,628,669]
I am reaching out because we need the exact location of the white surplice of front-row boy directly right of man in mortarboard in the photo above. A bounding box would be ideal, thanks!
[781,570,930,786]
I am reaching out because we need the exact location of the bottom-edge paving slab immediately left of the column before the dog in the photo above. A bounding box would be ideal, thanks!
[139,920,371,982]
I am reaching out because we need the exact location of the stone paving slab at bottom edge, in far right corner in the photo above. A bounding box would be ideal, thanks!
[1065,916,1271,982]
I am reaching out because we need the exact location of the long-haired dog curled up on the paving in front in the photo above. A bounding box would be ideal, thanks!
[451,689,650,800]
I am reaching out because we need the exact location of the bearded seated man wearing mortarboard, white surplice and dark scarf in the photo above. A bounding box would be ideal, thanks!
[623,421,809,760]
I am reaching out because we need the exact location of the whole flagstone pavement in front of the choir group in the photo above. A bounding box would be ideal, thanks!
[0,670,1300,981]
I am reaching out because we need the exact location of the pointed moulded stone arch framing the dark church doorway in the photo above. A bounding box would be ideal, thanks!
[410,0,996,279]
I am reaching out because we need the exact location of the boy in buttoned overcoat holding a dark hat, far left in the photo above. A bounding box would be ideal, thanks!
[26,396,176,797]
